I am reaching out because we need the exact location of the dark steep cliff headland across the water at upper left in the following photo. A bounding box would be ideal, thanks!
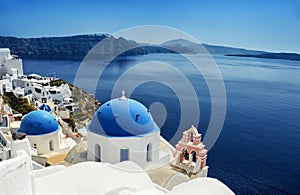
[0,34,145,60]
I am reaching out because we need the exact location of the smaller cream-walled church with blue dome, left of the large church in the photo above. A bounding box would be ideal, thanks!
[18,110,69,155]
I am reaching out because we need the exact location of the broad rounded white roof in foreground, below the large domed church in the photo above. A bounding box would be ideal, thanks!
[35,161,162,195]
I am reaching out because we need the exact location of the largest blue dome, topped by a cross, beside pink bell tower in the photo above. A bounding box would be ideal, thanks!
[88,97,159,137]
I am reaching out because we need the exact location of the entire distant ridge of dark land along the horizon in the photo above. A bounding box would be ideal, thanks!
[0,34,300,61]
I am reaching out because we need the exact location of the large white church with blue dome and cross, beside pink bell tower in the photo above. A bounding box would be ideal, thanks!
[87,91,169,168]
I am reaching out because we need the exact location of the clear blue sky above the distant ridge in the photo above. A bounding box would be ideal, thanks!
[0,0,300,53]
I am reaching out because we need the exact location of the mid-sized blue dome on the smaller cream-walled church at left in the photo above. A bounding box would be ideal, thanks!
[18,110,60,135]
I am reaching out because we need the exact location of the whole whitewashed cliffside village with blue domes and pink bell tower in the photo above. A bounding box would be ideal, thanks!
[0,49,233,195]
